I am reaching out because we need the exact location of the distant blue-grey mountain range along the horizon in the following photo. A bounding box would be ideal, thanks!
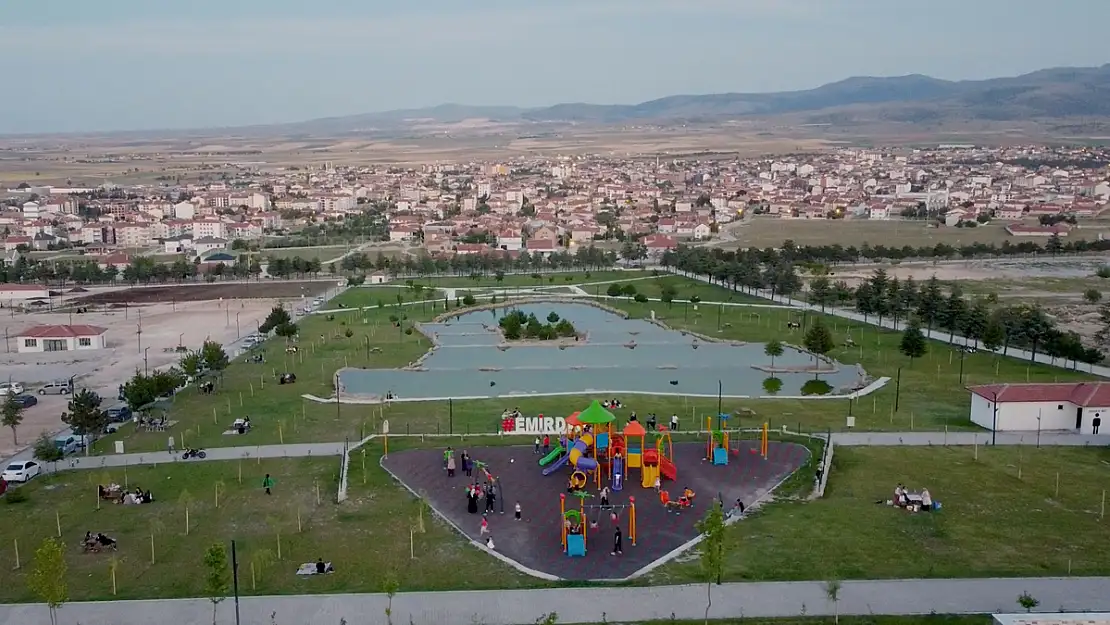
[279,63,1110,133]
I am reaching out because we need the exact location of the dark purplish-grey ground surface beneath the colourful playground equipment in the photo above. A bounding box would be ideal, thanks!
[382,441,809,579]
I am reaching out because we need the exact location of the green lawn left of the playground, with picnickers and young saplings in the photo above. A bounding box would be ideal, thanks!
[0,452,536,602]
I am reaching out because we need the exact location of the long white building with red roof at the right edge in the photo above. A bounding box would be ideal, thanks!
[968,382,1110,434]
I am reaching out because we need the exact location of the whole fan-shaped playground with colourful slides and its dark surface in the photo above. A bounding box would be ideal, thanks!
[382,402,809,581]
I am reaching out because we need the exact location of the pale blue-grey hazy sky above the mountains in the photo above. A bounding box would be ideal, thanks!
[0,0,1110,134]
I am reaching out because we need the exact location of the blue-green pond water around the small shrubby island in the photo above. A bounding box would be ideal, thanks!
[340,302,859,399]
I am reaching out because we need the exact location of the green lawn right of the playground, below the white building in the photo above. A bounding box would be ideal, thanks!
[650,446,1110,584]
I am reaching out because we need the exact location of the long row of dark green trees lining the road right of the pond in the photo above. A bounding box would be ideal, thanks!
[664,248,1110,364]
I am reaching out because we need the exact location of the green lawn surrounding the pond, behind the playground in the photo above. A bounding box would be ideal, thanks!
[88,278,1090,453]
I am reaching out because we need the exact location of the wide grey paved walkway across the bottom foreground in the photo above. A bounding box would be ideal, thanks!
[0,577,1110,625]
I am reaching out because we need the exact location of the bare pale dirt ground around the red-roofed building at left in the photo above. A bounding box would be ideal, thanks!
[0,282,334,458]
